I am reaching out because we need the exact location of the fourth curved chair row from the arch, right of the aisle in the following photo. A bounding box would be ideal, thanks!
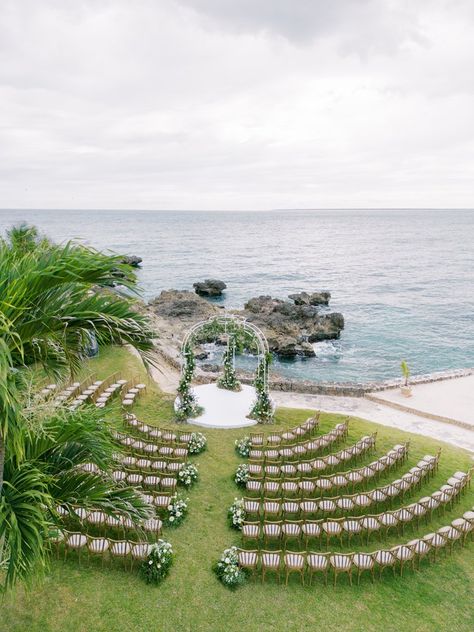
[246,443,409,496]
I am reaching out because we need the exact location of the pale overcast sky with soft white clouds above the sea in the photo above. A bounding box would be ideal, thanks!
[0,0,474,210]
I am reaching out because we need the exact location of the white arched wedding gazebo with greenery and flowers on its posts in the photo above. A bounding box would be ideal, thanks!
[177,314,273,423]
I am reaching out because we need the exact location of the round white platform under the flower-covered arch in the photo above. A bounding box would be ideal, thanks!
[181,384,257,428]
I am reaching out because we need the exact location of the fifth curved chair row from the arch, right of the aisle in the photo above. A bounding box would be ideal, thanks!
[244,453,439,517]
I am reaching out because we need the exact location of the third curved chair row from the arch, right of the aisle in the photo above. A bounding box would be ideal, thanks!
[248,432,377,478]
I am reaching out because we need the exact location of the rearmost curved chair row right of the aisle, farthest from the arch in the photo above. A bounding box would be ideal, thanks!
[238,511,474,586]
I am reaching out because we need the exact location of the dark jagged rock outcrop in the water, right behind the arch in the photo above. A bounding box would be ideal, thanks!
[239,296,344,358]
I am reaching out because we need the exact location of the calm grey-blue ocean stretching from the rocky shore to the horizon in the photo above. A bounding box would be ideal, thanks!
[0,210,474,382]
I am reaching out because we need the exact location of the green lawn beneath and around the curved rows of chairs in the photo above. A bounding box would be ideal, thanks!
[0,349,474,632]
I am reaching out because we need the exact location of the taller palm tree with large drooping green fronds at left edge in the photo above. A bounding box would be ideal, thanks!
[0,226,153,588]
